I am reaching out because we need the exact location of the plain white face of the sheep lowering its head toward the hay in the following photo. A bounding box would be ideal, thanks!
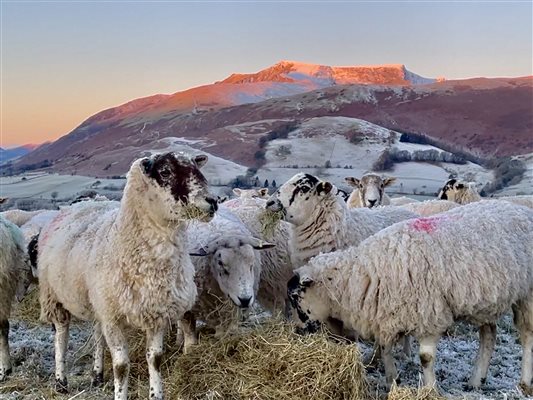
[191,236,274,308]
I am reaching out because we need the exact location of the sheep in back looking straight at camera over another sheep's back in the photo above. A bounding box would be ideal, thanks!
[345,174,396,208]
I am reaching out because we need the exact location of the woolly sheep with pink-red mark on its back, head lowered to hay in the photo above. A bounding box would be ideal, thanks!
[288,201,533,387]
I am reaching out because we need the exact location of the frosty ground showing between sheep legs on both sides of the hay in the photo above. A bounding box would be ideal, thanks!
[0,314,531,400]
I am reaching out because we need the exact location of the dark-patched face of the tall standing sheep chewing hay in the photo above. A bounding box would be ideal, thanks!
[140,153,218,221]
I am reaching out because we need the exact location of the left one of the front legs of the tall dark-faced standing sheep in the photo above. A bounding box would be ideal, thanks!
[102,322,130,400]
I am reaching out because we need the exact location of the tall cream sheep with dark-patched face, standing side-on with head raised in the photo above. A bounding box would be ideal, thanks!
[38,153,217,400]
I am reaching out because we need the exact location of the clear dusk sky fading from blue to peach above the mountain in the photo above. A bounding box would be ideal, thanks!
[0,0,533,147]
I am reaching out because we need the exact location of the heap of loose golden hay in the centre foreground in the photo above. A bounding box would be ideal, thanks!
[165,321,370,400]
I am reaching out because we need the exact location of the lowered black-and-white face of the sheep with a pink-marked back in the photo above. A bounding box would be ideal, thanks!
[287,269,331,334]
